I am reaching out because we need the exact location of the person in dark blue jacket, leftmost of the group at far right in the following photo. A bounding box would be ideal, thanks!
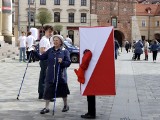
[134,40,143,60]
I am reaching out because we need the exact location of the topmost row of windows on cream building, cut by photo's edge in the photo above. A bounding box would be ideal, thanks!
[28,0,87,6]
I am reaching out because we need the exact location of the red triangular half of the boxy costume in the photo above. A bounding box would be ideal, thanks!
[83,30,116,95]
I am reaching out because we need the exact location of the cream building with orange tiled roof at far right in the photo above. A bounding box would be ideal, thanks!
[133,4,160,41]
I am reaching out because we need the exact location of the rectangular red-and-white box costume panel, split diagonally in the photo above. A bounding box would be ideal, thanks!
[79,27,116,96]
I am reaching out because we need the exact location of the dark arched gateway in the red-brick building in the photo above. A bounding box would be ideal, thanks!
[114,30,125,47]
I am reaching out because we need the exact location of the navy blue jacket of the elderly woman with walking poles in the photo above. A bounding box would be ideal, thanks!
[34,47,71,83]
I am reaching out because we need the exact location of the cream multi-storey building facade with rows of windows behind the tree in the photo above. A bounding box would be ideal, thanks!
[16,0,97,45]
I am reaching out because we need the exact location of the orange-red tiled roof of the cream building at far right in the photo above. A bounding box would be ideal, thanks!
[136,4,160,16]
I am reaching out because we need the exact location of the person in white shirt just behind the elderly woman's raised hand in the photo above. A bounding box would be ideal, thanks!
[26,32,36,62]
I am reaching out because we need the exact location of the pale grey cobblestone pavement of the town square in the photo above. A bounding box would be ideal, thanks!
[0,52,160,120]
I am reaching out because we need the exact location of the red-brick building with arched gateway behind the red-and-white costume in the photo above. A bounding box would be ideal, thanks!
[91,0,137,45]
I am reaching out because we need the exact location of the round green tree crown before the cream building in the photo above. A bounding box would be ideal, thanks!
[37,10,52,27]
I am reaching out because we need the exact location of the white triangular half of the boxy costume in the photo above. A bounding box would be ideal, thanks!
[79,27,113,95]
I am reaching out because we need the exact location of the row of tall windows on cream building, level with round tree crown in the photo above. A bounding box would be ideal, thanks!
[28,12,87,23]
